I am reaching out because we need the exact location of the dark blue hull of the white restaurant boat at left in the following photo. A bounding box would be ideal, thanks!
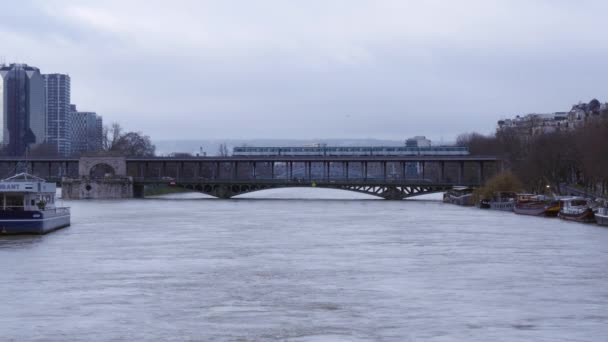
[0,210,70,235]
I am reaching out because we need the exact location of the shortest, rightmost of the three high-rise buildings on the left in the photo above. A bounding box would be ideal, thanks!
[70,105,103,154]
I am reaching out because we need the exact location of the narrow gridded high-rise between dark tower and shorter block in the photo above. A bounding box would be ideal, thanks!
[42,74,72,156]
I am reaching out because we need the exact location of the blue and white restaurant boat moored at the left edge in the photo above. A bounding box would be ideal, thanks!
[0,173,70,234]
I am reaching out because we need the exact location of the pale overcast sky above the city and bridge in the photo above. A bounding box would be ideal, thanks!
[0,0,608,141]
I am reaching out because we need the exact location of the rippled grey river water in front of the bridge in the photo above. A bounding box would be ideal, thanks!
[0,189,608,342]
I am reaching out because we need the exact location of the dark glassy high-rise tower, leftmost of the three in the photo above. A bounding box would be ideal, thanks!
[0,64,46,156]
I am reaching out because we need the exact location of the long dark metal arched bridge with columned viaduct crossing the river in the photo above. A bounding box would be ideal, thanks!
[0,156,502,199]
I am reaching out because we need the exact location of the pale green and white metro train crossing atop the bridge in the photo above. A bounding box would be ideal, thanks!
[232,146,469,157]
